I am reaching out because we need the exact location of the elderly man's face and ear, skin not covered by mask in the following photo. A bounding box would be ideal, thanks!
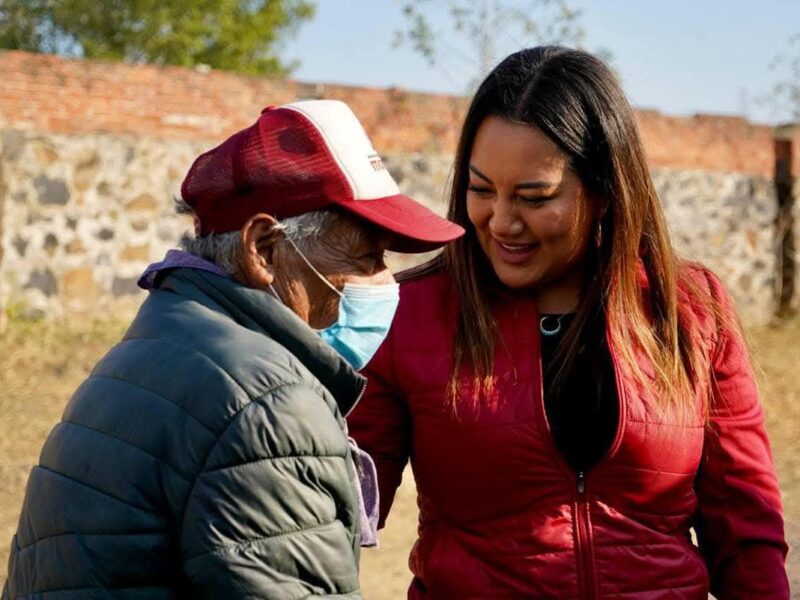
[237,214,394,329]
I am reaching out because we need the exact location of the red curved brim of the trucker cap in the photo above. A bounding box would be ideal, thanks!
[334,194,464,253]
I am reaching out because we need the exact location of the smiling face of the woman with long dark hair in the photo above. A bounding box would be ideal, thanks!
[467,116,593,312]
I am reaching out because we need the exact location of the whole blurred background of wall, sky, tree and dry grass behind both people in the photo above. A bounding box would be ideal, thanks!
[0,0,800,599]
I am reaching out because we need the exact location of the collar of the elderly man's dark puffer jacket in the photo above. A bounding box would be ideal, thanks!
[159,268,367,416]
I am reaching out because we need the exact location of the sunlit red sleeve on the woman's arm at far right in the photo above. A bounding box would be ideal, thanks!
[695,274,789,600]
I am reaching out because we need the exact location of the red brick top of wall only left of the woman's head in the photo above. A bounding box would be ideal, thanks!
[0,52,464,152]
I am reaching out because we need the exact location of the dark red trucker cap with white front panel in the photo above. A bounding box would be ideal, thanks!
[181,100,464,252]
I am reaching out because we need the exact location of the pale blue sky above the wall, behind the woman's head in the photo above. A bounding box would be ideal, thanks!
[283,0,800,123]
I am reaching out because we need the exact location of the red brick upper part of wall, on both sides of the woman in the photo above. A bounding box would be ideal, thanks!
[0,52,775,176]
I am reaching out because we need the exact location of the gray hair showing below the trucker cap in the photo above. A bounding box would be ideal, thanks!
[175,198,341,274]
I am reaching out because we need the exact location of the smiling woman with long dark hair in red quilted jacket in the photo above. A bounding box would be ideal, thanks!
[349,47,789,599]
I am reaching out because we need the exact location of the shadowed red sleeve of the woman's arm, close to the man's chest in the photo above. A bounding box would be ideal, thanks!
[347,333,411,528]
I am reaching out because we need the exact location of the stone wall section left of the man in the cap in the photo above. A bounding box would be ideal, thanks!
[0,130,202,316]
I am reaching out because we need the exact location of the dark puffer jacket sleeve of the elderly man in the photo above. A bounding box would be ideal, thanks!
[180,385,361,600]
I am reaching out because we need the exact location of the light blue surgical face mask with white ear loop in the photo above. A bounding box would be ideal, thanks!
[276,230,400,370]
